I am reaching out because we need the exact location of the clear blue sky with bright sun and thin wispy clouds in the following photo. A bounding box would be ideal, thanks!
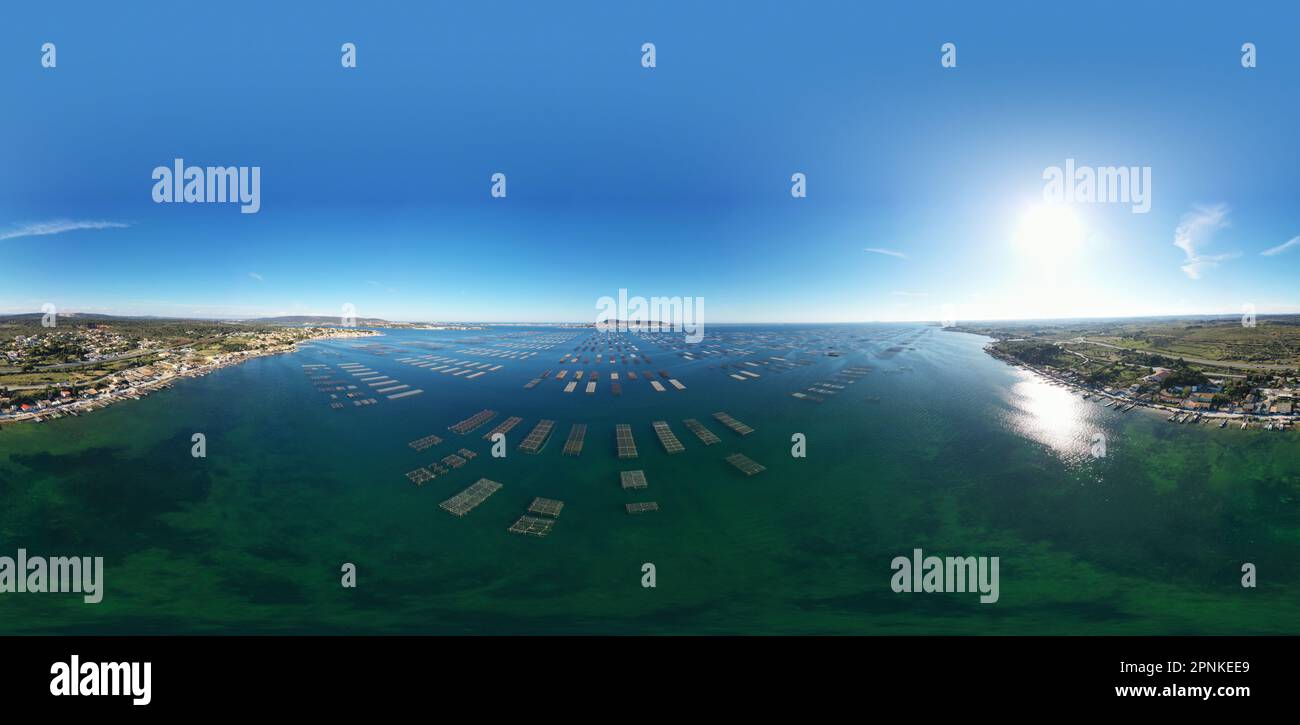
[0,1,1300,322]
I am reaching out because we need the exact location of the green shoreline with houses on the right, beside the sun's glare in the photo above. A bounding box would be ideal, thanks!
[952,316,1300,430]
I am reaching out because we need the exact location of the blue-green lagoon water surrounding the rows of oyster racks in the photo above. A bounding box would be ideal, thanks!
[0,325,1300,634]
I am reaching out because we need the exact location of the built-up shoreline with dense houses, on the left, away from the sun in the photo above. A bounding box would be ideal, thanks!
[0,313,382,425]
